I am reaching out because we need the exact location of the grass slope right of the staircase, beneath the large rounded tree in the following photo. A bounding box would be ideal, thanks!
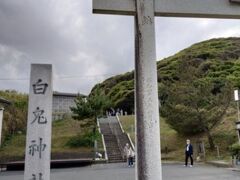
[120,114,236,161]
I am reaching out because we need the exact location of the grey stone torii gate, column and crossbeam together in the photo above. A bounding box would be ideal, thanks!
[93,0,240,180]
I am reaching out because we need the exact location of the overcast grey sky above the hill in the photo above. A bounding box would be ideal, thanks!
[0,0,240,94]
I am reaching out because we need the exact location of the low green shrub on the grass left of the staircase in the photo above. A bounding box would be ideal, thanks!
[66,132,100,148]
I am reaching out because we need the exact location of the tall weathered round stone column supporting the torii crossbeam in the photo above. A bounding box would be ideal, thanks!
[135,0,162,180]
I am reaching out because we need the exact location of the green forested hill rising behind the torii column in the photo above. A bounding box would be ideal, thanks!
[91,38,240,113]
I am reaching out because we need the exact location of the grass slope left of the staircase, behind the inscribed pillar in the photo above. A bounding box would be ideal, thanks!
[0,119,102,162]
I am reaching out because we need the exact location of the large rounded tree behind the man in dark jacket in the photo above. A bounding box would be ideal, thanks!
[160,62,231,149]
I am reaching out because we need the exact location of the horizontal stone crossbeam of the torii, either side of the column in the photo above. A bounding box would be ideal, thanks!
[93,0,240,19]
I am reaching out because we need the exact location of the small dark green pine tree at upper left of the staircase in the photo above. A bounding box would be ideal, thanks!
[71,88,111,132]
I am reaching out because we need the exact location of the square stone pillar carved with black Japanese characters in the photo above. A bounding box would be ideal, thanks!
[24,64,53,180]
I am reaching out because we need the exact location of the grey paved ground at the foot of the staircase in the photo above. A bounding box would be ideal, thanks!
[0,164,240,180]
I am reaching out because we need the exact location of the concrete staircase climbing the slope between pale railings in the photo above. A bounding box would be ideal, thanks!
[98,117,134,163]
